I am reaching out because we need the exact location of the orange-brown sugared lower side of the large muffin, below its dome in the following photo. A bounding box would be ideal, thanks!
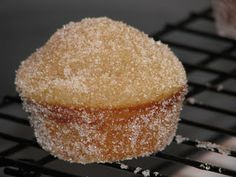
[25,88,186,163]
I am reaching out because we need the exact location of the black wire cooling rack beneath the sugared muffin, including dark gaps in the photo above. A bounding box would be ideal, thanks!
[0,9,236,177]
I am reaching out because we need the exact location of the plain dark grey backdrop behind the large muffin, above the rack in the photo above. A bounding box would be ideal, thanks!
[0,0,209,97]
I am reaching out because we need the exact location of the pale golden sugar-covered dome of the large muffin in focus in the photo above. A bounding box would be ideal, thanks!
[15,17,186,108]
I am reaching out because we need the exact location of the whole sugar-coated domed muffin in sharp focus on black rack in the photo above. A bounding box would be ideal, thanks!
[15,17,187,164]
